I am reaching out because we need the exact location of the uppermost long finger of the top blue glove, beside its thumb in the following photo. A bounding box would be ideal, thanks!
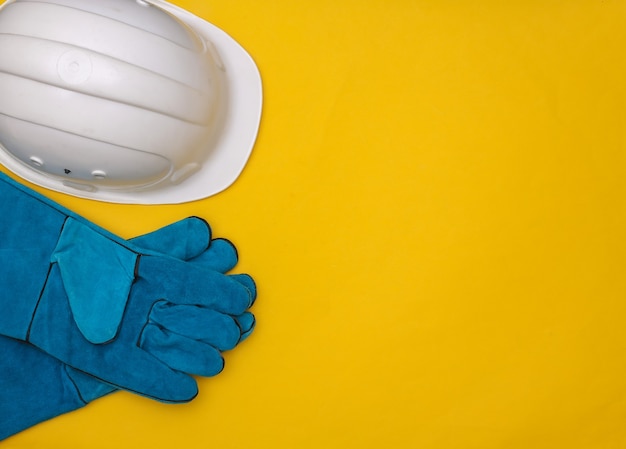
[136,256,253,315]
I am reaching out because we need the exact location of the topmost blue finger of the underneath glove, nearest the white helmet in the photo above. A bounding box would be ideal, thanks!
[129,217,211,260]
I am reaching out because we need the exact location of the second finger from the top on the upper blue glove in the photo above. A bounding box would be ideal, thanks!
[150,301,241,351]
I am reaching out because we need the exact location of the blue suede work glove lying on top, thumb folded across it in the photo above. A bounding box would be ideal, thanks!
[0,175,256,402]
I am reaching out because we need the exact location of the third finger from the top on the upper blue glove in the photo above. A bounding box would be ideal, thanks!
[141,324,224,377]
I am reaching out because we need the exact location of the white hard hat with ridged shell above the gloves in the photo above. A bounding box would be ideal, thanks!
[0,0,262,204]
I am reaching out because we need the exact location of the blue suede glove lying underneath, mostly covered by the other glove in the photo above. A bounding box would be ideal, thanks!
[0,217,255,440]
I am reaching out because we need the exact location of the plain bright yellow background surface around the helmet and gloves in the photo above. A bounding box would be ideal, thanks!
[2,0,626,449]
